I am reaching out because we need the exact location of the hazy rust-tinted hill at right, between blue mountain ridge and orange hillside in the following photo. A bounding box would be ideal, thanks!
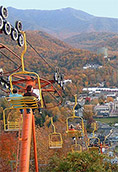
[64,32,118,52]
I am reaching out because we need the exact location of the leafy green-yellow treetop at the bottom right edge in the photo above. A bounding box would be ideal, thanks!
[47,151,118,172]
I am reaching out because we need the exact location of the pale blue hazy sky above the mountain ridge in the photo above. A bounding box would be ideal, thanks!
[0,0,118,18]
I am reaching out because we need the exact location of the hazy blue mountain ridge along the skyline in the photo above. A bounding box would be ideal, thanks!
[8,7,118,39]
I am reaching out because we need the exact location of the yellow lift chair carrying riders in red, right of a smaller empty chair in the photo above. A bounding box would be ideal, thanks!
[66,95,84,137]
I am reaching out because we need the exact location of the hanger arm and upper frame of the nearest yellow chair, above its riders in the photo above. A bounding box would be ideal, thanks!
[9,32,43,108]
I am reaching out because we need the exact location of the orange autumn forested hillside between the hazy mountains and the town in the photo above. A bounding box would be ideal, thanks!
[0,31,118,94]
